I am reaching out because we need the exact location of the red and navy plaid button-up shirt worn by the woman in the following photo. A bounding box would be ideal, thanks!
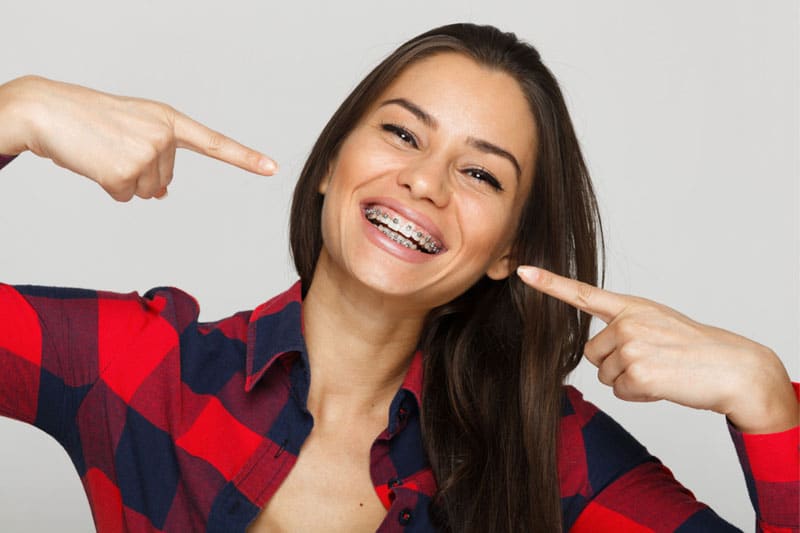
[0,152,800,532]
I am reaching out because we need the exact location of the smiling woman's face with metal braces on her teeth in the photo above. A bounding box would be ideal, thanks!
[315,53,536,309]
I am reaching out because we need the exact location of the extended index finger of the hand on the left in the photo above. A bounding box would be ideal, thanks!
[175,111,278,176]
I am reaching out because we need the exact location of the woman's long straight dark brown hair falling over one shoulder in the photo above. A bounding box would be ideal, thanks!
[290,24,605,532]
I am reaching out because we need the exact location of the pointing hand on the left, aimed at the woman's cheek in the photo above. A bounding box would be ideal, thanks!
[0,76,277,202]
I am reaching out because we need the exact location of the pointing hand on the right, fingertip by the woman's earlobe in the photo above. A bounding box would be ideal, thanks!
[517,266,800,433]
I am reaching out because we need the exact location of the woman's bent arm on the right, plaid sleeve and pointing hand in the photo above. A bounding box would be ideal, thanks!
[519,267,800,532]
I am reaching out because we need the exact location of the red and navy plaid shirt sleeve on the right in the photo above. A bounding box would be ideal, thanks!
[559,387,800,532]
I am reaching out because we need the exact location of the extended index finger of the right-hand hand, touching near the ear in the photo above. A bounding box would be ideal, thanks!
[517,266,627,324]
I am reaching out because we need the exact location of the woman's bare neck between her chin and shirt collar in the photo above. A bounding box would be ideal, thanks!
[303,252,425,423]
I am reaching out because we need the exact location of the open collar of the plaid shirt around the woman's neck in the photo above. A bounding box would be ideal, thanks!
[244,281,423,407]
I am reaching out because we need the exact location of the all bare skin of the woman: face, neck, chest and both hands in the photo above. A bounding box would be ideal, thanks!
[0,54,800,531]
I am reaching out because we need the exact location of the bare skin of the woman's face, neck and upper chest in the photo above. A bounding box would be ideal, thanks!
[252,54,535,531]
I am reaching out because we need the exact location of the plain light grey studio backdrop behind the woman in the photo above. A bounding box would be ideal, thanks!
[0,0,800,532]
